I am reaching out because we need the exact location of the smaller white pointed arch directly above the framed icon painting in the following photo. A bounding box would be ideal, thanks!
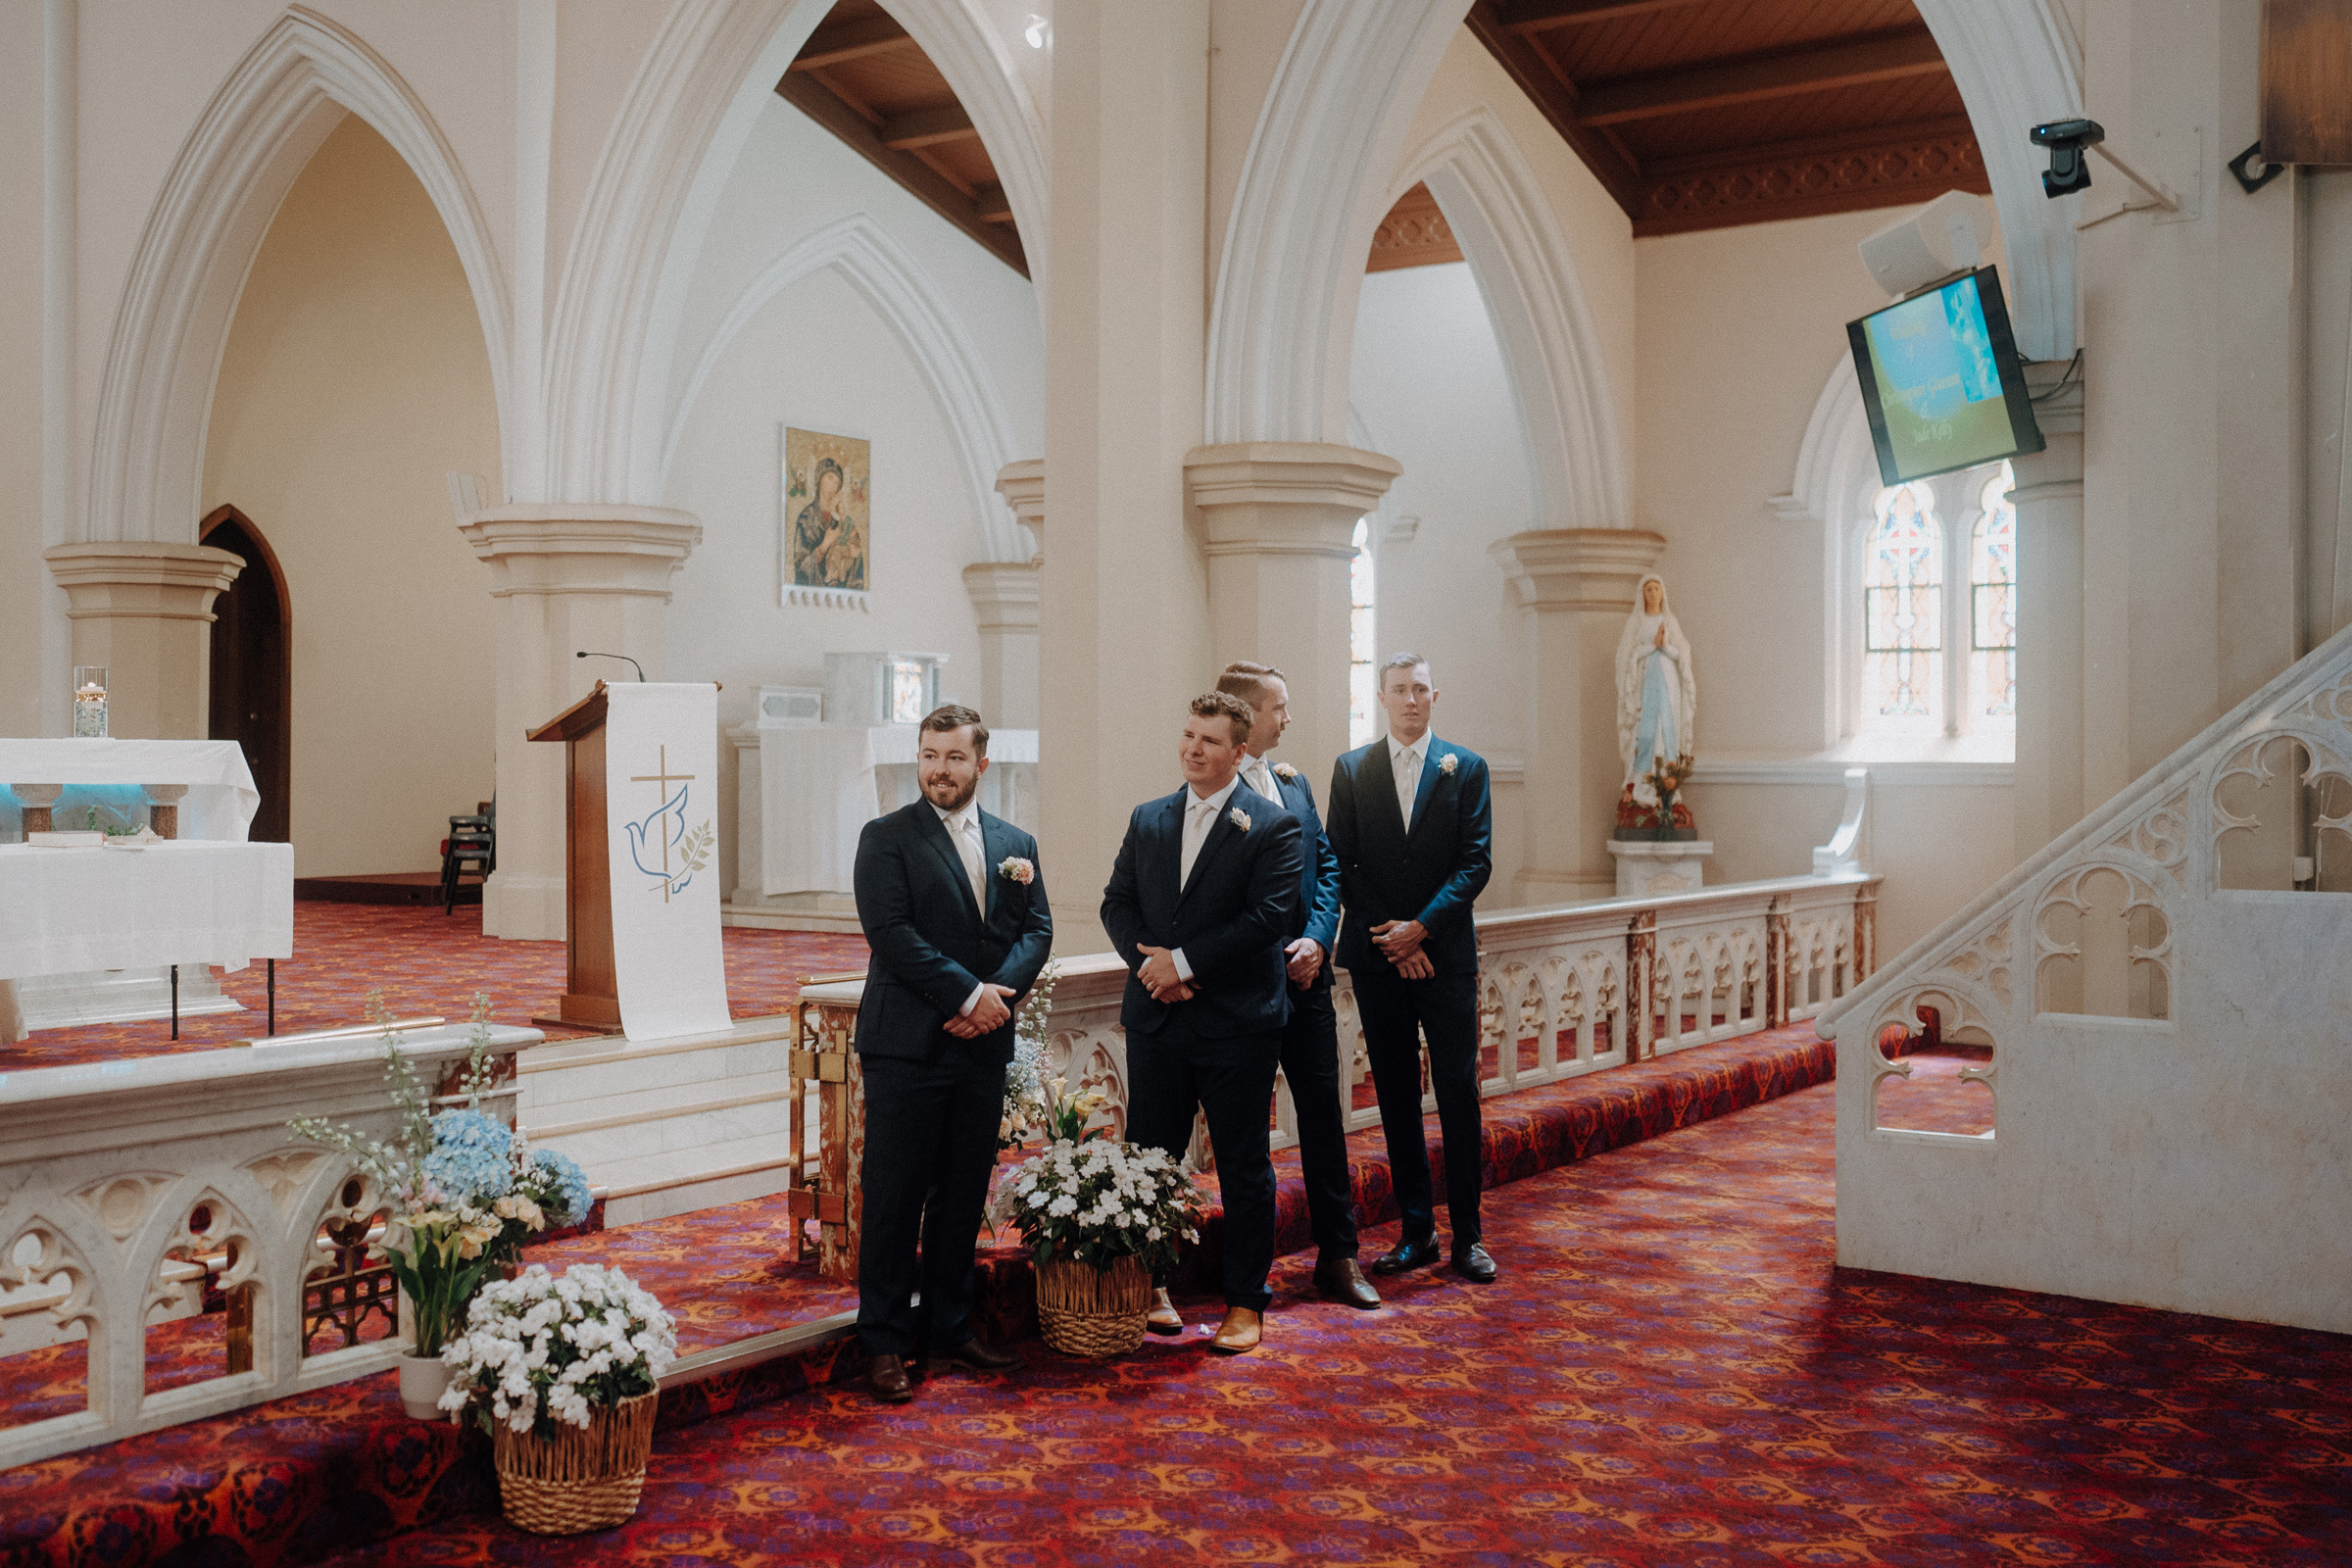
[661,212,1030,562]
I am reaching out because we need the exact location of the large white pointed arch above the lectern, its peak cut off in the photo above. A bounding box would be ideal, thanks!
[546,0,1049,506]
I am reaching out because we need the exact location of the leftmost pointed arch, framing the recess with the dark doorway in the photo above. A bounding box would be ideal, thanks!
[80,5,511,543]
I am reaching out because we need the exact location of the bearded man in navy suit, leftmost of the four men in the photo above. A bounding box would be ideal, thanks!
[857,706,1054,1403]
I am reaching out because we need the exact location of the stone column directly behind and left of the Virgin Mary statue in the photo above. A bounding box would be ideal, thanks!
[1492,529,1665,903]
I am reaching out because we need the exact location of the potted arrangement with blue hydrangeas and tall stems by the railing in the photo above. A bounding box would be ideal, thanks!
[287,992,590,1420]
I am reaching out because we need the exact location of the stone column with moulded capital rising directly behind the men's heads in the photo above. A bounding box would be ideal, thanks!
[1186,442,1404,790]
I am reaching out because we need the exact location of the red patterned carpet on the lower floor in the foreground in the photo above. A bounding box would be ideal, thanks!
[318,1086,2352,1568]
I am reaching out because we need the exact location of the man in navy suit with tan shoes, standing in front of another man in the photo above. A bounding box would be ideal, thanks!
[1103,691,1300,1354]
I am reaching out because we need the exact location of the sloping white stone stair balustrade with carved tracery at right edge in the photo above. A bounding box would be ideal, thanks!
[1818,627,2352,1333]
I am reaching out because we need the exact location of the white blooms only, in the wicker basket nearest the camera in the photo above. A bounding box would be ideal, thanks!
[440,1262,677,1437]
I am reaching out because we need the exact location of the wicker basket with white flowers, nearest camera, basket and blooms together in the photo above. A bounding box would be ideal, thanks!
[442,1262,677,1535]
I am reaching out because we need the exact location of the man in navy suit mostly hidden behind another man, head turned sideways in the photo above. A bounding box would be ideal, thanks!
[1216,661,1381,1312]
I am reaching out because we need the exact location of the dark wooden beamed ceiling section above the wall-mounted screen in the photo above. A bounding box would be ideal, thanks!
[1465,0,1985,232]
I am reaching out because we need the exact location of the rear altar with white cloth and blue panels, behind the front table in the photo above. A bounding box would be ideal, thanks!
[0,736,269,1039]
